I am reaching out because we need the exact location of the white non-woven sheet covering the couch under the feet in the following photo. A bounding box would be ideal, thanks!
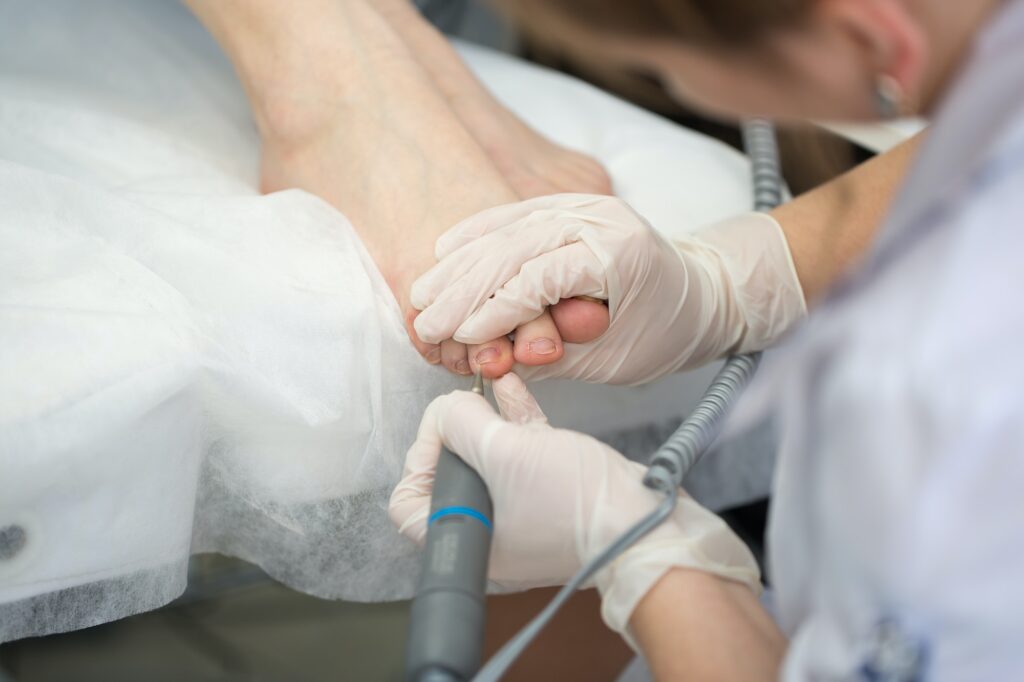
[0,0,750,641]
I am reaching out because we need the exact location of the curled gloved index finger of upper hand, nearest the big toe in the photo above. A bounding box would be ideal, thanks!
[454,242,608,343]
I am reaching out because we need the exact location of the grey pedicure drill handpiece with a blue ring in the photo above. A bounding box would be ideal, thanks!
[406,373,493,682]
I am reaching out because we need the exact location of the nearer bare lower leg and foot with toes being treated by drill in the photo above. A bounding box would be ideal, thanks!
[189,0,607,378]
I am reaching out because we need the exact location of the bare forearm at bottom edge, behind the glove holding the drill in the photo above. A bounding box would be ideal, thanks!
[630,568,786,682]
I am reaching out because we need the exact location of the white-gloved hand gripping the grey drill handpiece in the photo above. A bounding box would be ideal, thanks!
[388,374,760,632]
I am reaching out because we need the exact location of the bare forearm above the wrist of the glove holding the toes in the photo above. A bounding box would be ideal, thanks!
[772,133,924,303]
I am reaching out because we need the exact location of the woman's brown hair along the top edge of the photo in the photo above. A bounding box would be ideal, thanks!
[498,0,814,45]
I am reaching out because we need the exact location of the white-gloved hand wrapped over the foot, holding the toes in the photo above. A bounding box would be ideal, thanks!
[412,195,806,384]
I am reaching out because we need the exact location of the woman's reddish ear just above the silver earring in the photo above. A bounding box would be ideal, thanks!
[815,0,928,102]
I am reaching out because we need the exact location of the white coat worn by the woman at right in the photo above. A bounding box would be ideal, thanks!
[761,1,1024,682]
